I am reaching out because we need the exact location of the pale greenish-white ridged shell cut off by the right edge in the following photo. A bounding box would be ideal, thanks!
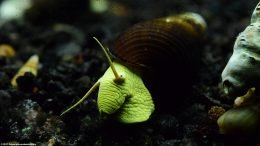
[222,2,260,96]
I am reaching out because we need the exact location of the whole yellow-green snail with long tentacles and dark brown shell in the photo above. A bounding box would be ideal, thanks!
[61,12,206,123]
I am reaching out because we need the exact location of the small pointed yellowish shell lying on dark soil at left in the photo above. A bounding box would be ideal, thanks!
[11,55,39,87]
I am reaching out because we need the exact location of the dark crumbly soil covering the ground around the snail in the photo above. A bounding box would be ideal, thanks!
[0,0,259,146]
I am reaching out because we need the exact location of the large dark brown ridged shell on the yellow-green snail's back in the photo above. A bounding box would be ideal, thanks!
[110,12,206,111]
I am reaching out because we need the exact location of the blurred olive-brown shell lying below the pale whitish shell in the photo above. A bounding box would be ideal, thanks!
[217,87,260,135]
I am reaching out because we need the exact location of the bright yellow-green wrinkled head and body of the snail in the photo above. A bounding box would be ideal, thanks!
[97,62,154,123]
